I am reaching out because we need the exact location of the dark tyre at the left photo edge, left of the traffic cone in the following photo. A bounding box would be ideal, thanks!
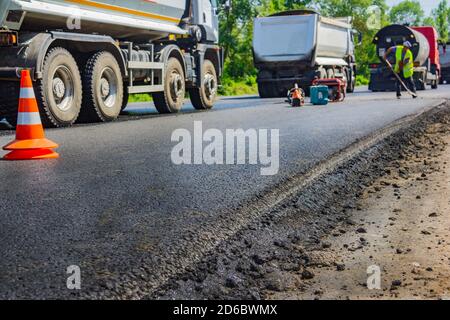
[0,81,20,126]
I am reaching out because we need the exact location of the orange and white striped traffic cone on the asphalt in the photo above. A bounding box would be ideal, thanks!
[3,70,59,160]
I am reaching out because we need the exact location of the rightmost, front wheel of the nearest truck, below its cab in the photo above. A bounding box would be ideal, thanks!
[189,60,218,110]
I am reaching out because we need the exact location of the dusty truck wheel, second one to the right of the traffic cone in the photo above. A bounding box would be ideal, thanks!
[80,51,124,122]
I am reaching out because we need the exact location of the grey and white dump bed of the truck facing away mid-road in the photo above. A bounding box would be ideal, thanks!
[253,14,351,65]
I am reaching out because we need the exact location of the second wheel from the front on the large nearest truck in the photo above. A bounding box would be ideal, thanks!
[153,58,186,113]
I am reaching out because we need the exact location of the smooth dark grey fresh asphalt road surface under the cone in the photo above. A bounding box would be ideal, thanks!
[0,86,450,298]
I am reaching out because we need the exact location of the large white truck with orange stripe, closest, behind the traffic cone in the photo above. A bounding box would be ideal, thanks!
[0,0,223,127]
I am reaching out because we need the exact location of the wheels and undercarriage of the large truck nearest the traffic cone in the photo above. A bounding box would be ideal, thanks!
[0,30,223,127]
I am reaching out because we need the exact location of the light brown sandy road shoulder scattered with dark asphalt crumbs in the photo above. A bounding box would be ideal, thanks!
[270,119,450,299]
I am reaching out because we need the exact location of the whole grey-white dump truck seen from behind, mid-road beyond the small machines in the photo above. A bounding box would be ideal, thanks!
[253,10,360,98]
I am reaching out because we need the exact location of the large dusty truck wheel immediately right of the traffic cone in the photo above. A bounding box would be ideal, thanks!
[35,47,82,127]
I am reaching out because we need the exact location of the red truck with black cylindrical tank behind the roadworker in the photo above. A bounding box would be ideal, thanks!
[369,24,441,92]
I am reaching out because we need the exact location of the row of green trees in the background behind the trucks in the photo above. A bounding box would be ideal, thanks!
[219,0,450,94]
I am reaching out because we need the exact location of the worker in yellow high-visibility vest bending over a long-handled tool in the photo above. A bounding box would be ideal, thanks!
[384,41,417,99]
